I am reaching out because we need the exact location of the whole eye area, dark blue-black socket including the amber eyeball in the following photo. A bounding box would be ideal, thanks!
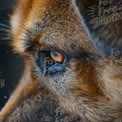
[37,50,68,76]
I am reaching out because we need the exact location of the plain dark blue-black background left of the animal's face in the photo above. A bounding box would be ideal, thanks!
[0,0,24,109]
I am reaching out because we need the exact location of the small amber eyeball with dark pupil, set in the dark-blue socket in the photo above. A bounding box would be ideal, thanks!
[50,51,65,63]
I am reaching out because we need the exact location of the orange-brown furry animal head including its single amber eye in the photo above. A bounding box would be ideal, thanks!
[3,0,122,121]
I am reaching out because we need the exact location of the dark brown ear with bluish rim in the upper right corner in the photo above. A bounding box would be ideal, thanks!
[75,0,122,56]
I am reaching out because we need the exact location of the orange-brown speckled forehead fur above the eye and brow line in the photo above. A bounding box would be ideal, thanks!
[12,0,97,58]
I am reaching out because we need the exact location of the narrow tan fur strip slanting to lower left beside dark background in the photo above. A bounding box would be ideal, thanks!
[0,58,37,119]
